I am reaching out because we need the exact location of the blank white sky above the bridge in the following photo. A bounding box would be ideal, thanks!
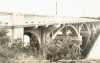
[0,0,100,17]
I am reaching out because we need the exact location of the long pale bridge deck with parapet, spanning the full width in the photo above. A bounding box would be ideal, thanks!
[0,12,100,28]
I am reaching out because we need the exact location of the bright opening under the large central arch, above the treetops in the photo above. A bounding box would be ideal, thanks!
[50,25,78,38]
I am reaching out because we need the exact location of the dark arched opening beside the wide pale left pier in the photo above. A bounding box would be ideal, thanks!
[24,32,40,51]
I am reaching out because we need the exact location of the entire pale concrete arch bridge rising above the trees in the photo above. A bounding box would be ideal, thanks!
[0,12,100,59]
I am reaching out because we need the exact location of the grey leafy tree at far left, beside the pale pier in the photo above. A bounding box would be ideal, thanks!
[0,29,14,63]
